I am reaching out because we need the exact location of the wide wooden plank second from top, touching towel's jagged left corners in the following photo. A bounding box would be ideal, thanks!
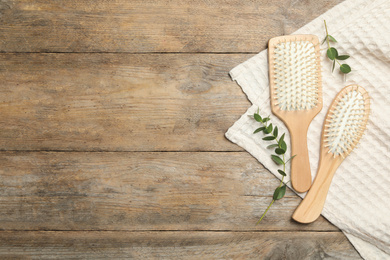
[0,54,252,151]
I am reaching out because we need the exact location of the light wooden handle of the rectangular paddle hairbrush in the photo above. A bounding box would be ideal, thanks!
[290,122,311,192]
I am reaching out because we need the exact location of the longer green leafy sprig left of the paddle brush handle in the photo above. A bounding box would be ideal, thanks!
[253,111,295,225]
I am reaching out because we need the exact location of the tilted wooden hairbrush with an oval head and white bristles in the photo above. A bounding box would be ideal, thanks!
[292,85,370,223]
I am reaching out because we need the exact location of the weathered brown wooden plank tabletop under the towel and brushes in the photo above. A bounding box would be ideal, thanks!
[0,0,360,259]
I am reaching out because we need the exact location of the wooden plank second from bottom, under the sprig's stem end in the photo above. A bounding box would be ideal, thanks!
[0,152,338,231]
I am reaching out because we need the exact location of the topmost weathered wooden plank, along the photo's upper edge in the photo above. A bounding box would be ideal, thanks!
[0,0,342,52]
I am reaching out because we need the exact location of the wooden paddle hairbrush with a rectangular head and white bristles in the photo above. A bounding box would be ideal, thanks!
[268,35,322,192]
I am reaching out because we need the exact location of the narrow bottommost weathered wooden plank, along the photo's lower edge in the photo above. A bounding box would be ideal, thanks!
[0,231,361,260]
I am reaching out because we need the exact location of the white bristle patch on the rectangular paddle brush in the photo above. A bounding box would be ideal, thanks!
[273,40,320,110]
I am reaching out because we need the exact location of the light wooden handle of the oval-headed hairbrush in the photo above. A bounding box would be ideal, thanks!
[292,154,341,223]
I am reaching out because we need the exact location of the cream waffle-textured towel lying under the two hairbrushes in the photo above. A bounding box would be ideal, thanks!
[226,0,390,259]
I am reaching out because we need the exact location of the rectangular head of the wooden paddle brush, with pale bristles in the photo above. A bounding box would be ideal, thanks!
[269,35,322,111]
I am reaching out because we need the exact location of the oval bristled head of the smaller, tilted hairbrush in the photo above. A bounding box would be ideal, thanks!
[322,85,370,158]
